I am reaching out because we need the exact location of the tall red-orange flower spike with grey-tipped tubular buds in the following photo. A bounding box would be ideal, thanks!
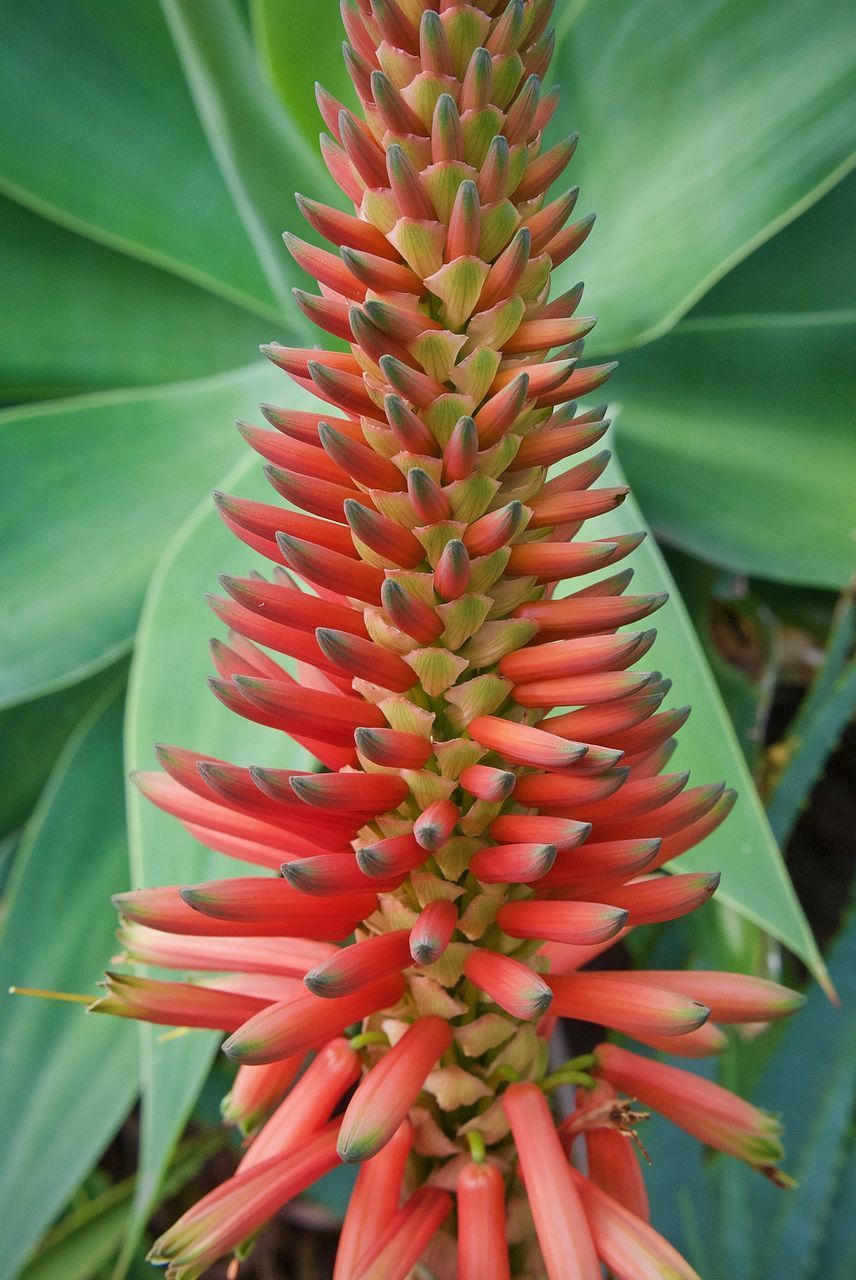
[95,0,797,1280]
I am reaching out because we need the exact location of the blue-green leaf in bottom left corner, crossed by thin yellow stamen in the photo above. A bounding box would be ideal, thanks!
[0,695,138,1280]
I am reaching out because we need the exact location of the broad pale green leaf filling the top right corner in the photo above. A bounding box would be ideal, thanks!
[553,0,855,351]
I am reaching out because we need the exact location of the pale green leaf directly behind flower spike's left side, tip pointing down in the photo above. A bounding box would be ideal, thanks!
[118,450,317,1274]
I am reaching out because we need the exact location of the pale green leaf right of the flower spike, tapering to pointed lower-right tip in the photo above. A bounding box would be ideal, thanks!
[559,445,825,980]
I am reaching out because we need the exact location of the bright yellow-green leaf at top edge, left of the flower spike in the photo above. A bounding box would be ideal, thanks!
[250,0,357,147]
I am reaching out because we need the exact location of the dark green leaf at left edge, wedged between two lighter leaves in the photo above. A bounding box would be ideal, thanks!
[0,197,269,401]
